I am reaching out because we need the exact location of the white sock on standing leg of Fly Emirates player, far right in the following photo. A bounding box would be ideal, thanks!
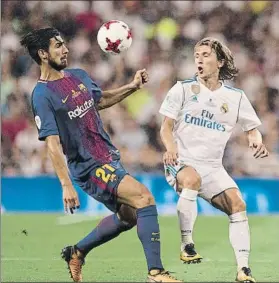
[229,211,250,270]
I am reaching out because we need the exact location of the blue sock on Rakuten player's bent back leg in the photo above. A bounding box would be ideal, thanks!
[76,214,132,256]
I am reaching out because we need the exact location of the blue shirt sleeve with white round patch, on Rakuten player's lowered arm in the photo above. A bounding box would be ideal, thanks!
[32,92,59,141]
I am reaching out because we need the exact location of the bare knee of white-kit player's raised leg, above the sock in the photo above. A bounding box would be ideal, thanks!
[177,167,201,191]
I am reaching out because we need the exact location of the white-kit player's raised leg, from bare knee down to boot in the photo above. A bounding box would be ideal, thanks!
[176,166,202,264]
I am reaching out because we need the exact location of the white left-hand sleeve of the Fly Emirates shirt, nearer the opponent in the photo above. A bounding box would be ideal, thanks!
[159,82,184,120]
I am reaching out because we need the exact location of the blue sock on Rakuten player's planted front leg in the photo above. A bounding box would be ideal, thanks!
[137,205,163,271]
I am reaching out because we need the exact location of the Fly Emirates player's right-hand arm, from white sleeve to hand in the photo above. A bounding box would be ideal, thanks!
[238,92,269,158]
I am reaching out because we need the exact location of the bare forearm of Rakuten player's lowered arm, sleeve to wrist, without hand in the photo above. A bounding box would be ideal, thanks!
[46,135,72,187]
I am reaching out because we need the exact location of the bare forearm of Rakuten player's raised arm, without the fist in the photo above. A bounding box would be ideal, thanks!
[97,83,139,110]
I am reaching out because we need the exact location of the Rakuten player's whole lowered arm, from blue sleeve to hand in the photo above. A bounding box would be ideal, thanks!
[32,89,79,213]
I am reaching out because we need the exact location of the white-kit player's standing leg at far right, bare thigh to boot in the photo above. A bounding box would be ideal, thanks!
[212,188,256,282]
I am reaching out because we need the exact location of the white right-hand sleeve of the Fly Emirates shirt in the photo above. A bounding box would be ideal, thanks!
[238,92,262,132]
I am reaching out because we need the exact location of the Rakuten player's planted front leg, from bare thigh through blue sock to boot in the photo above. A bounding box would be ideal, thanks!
[117,175,181,282]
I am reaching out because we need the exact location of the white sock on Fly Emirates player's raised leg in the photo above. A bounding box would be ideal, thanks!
[177,188,198,251]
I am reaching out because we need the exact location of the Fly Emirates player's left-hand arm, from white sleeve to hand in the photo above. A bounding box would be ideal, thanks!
[159,82,184,166]
